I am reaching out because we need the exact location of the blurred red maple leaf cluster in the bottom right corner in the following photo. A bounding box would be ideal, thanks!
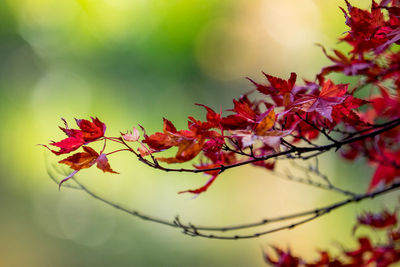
[264,210,400,267]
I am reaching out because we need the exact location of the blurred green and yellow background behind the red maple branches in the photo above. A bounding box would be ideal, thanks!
[0,0,392,267]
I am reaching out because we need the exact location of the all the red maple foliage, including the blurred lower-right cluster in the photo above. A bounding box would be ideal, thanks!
[46,0,400,266]
